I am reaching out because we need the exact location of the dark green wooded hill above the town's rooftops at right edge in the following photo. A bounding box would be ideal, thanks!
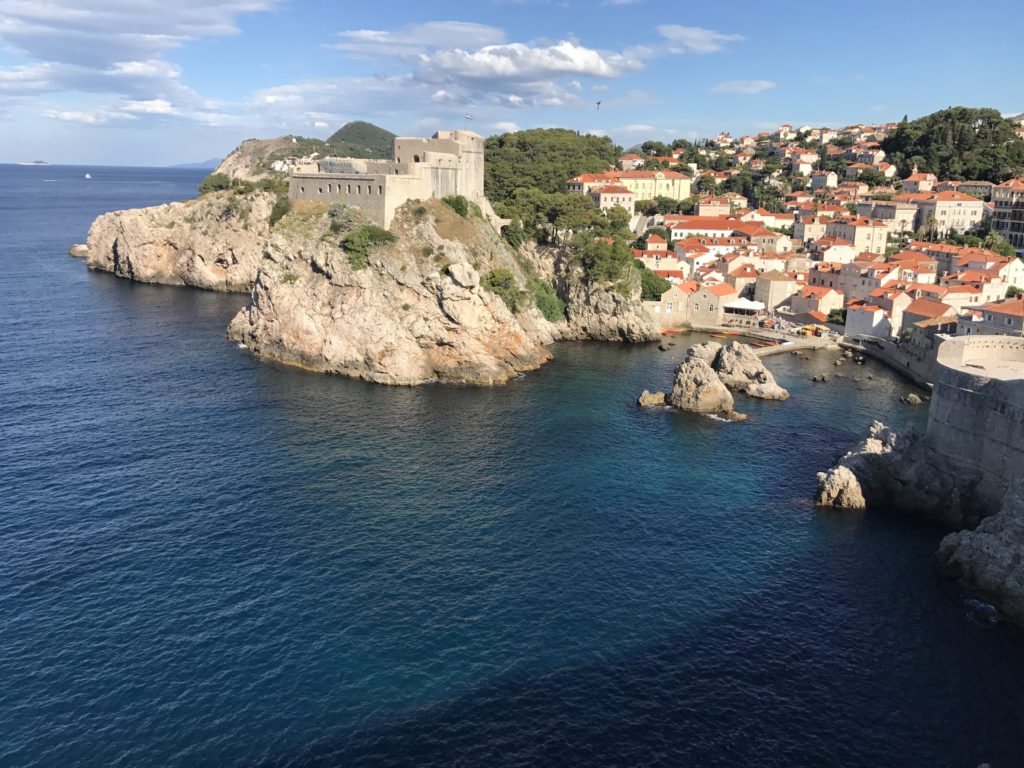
[882,106,1024,183]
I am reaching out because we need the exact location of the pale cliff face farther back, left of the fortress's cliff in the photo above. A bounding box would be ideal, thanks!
[86,191,274,291]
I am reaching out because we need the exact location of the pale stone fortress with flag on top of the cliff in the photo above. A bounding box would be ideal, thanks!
[288,131,497,228]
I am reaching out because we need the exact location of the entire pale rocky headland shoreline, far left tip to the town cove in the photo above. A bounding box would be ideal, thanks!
[77,191,660,385]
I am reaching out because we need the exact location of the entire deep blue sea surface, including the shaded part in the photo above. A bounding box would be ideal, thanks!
[0,166,1024,768]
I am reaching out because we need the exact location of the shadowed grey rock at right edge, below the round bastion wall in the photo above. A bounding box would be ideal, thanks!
[938,483,1024,626]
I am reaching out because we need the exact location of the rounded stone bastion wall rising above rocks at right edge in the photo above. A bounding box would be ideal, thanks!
[926,336,1024,490]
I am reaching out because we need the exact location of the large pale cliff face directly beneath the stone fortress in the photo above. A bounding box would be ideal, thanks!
[228,202,558,385]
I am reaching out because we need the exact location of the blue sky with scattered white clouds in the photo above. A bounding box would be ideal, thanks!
[0,0,1024,165]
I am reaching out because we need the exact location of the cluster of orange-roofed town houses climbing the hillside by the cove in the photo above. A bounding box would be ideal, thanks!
[567,124,1024,358]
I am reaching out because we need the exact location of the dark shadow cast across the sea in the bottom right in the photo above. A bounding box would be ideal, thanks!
[260,532,1024,768]
